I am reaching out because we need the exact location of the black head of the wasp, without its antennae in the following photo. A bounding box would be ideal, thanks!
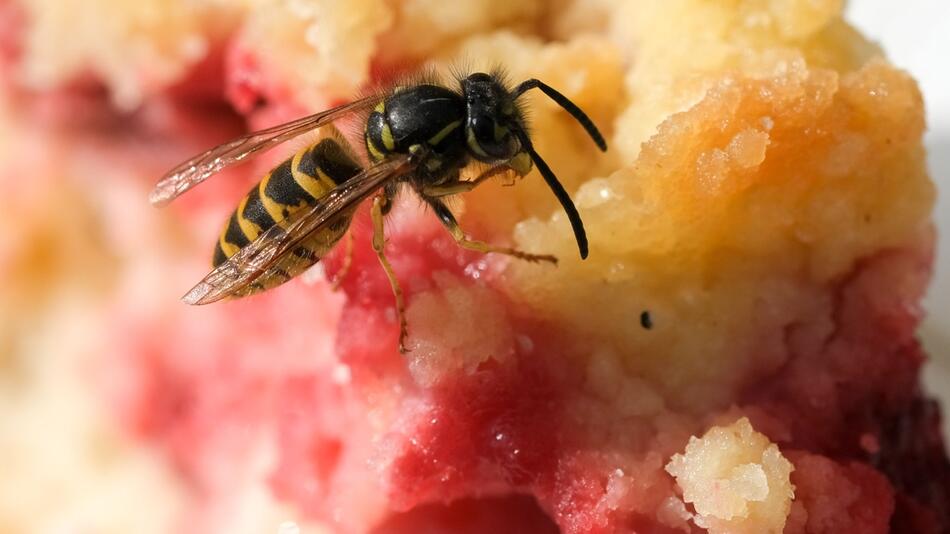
[462,72,520,161]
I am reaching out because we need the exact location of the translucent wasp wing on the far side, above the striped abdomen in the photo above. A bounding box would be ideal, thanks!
[148,96,380,206]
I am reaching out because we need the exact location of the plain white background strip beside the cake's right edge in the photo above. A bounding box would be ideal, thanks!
[847,0,950,438]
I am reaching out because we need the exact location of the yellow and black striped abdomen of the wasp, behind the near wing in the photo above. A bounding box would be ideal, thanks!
[213,139,361,294]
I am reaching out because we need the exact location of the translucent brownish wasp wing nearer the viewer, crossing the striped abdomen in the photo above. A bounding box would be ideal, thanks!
[182,156,412,304]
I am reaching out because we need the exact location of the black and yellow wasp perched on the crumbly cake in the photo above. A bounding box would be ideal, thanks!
[149,72,607,352]
